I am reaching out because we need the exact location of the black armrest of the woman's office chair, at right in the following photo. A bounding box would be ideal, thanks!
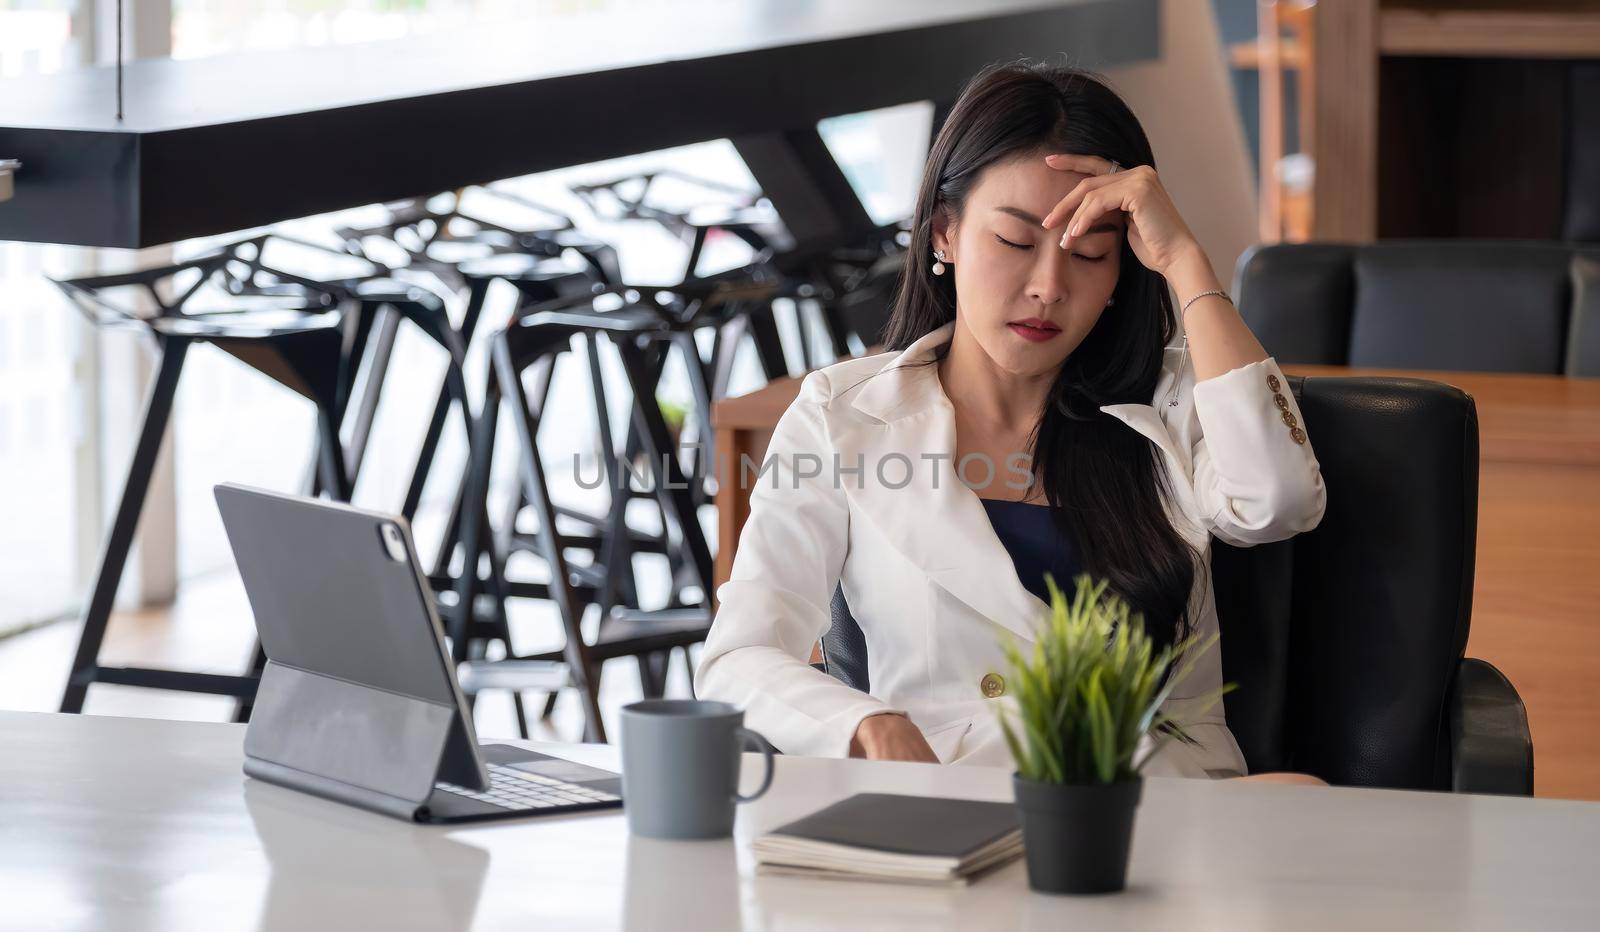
[1450,657,1533,796]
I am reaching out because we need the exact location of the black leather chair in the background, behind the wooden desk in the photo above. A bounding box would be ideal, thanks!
[1234,240,1600,376]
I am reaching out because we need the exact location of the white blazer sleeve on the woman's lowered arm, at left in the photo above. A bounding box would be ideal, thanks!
[694,372,914,757]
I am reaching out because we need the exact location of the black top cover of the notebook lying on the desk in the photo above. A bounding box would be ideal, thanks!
[771,793,1018,858]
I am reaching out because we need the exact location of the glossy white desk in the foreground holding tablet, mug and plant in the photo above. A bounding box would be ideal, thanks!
[0,713,1600,932]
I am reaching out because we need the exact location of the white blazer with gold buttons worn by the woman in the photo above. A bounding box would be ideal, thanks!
[694,322,1325,777]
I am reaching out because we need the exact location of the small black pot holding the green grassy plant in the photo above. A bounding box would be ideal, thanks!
[1011,773,1144,894]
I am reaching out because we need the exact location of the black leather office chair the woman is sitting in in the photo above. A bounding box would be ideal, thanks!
[822,378,1533,794]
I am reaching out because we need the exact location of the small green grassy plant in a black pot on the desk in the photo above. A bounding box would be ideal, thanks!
[1000,575,1230,894]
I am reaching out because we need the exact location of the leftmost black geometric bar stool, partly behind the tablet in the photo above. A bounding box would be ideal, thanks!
[58,234,472,721]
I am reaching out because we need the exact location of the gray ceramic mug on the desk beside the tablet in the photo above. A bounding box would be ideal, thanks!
[622,700,773,838]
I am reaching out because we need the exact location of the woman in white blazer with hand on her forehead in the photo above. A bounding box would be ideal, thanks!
[696,64,1325,777]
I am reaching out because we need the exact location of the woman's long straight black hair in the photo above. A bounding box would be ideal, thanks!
[885,62,1195,645]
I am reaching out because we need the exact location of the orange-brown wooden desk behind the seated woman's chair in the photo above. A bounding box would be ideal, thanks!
[712,365,1600,799]
